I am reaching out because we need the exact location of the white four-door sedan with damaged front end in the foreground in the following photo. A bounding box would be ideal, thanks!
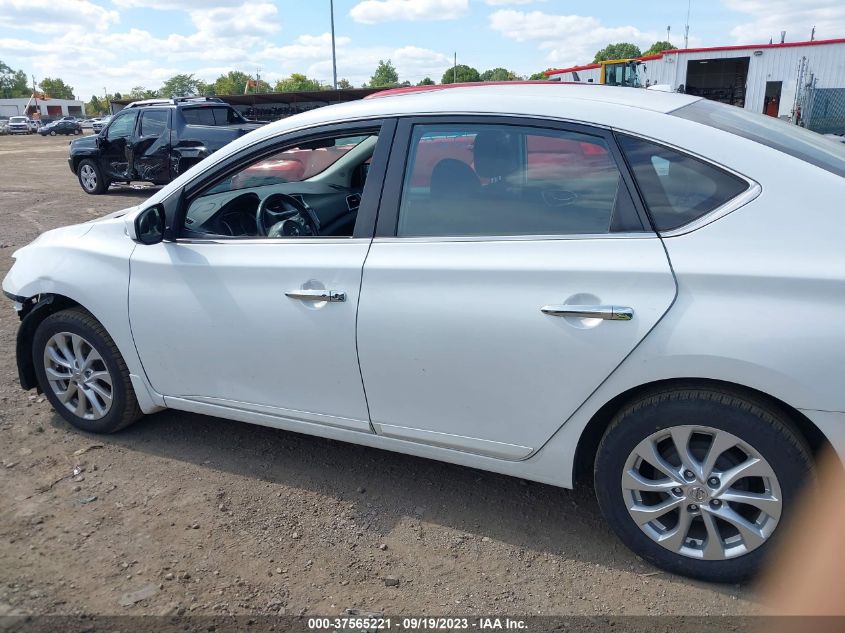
[3,84,845,581]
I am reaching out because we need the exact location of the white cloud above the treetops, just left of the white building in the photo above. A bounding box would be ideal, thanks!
[490,9,660,65]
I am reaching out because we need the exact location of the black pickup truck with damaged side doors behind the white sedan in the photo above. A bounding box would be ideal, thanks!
[68,97,260,194]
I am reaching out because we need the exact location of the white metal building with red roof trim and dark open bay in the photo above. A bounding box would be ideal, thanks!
[546,39,845,132]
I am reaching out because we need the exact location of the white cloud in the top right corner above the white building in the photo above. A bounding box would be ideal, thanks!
[723,0,845,44]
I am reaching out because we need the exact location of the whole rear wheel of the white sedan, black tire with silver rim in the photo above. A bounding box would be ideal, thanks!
[594,387,812,582]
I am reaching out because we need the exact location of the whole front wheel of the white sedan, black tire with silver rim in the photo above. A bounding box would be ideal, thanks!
[32,308,142,433]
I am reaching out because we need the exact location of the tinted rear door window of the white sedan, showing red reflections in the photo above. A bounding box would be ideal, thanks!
[397,124,631,236]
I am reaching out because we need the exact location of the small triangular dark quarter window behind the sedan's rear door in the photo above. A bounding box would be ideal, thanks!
[618,134,748,231]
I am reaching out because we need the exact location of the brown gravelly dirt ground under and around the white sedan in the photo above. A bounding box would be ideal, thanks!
[0,132,755,616]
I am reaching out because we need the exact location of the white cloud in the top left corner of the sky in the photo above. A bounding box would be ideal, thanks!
[0,0,120,33]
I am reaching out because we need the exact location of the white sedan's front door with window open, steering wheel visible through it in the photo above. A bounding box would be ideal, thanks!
[129,121,393,432]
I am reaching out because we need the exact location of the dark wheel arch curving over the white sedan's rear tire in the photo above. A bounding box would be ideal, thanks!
[572,378,830,486]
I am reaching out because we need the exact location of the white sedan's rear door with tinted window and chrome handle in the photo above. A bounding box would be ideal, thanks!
[358,117,676,460]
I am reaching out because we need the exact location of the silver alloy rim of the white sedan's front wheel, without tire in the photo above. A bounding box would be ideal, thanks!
[44,332,114,420]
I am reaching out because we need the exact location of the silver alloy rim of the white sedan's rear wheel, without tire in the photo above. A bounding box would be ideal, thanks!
[621,426,782,561]
